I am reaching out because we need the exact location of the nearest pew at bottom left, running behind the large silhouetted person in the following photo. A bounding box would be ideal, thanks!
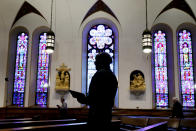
[0,120,121,131]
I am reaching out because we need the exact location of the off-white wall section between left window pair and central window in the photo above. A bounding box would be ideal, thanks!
[49,0,94,107]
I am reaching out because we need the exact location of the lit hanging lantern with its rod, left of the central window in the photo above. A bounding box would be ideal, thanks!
[46,0,55,54]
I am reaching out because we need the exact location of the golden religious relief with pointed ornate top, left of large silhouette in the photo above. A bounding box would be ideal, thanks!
[55,63,71,91]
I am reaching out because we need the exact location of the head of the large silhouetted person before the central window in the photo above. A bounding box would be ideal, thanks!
[95,52,112,70]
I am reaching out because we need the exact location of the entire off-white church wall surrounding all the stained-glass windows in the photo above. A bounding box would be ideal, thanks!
[0,0,195,109]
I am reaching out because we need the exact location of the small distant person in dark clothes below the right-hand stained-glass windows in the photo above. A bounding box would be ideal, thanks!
[172,97,184,118]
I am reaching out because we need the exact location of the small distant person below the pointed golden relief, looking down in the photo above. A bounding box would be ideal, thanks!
[56,97,67,118]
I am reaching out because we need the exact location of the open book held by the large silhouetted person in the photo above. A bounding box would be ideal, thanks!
[69,90,87,104]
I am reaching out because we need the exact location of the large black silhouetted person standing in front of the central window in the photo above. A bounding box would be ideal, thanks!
[71,53,118,130]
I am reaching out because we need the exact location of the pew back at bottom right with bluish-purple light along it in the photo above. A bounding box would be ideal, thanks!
[134,121,167,131]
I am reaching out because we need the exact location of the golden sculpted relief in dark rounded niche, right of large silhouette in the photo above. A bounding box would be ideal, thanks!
[130,72,146,95]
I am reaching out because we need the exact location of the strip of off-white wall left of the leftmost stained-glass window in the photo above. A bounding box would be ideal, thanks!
[0,0,23,107]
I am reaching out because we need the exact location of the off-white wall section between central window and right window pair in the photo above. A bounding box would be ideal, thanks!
[110,1,152,109]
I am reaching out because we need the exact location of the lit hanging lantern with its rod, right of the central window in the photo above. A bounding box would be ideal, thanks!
[142,0,152,53]
